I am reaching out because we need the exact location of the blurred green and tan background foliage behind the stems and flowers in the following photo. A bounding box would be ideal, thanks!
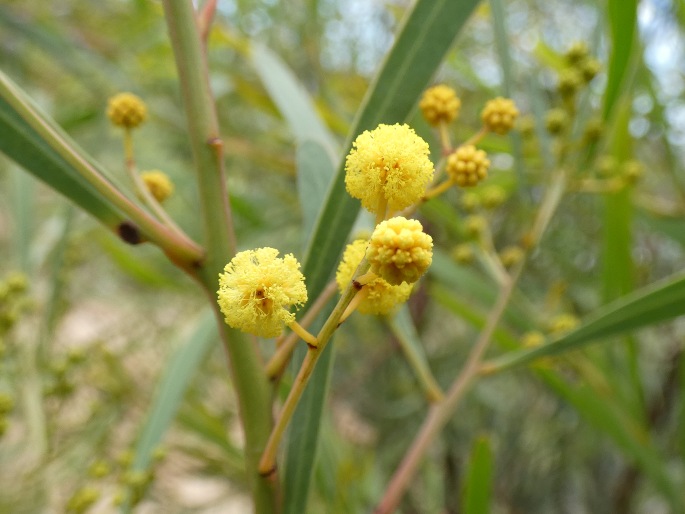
[0,0,685,514]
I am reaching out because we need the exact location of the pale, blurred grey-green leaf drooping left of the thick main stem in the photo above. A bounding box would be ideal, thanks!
[122,310,218,512]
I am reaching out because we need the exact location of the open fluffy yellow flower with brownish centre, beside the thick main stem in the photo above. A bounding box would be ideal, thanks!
[217,248,307,337]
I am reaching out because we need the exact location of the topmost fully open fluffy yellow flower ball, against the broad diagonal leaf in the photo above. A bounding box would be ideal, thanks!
[345,124,433,214]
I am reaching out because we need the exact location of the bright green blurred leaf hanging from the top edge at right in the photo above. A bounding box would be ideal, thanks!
[603,0,637,120]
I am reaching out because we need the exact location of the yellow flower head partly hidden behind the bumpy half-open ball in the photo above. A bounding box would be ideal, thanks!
[335,239,411,314]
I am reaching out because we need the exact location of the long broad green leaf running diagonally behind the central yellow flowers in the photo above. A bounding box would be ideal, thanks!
[284,0,478,514]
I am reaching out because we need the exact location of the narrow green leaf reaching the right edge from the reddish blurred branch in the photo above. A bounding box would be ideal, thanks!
[483,273,685,373]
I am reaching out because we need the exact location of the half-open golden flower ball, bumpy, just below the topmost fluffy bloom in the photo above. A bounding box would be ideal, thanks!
[366,216,433,285]
